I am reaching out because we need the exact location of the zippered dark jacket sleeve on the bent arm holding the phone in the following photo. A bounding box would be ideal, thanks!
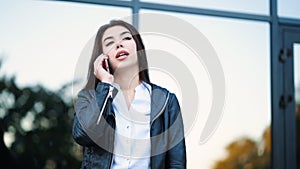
[72,82,112,146]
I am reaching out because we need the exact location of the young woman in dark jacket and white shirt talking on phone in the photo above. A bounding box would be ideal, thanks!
[73,20,186,169]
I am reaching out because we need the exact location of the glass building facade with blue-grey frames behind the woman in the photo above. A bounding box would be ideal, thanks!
[0,0,300,169]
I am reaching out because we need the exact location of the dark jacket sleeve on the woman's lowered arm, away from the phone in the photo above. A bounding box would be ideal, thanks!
[166,94,186,169]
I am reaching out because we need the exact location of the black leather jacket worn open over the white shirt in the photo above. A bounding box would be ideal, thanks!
[73,82,186,169]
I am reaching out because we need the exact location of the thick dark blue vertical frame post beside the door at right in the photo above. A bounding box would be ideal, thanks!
[270,0,285,169]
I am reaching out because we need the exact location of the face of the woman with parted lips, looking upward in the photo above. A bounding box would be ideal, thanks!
[102,25,138,71]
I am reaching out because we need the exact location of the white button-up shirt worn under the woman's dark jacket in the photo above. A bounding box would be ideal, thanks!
[112,82,151,169]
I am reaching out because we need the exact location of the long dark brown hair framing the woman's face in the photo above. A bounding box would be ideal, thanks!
[84,20,150,89]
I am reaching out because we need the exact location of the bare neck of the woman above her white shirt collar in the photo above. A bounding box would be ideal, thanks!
[114,67,140,91]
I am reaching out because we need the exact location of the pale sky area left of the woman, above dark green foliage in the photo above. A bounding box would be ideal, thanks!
[0,1,130,90]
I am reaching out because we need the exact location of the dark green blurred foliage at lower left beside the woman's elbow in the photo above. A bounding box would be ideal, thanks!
[0,69,82,169]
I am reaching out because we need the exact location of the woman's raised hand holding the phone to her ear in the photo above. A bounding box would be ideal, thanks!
[94,54,114,84]
